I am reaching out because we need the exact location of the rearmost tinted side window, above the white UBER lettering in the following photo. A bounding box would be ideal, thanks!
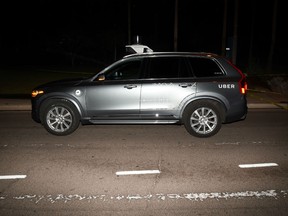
[188,57,224,77]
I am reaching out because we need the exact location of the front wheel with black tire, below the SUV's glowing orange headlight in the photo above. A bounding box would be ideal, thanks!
[41,100,80,136]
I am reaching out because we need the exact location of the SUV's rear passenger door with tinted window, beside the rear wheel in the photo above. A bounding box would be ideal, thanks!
[140,56,196,119]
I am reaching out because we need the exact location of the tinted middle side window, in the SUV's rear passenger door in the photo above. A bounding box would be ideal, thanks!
[149,57,191,78]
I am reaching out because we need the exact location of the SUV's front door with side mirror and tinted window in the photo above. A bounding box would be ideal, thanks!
[86,60,141,118]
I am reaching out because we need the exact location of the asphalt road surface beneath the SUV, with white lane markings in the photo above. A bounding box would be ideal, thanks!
[0,109,288,216]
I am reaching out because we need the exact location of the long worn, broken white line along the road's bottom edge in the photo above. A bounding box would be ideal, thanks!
[0,190,288,204]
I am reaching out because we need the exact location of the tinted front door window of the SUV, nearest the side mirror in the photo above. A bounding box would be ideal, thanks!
[105,60,141,80]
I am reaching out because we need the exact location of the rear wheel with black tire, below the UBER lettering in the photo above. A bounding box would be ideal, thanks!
[183,101,222,137]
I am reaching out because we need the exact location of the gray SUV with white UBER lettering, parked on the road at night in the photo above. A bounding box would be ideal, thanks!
[32,48,247,137]
